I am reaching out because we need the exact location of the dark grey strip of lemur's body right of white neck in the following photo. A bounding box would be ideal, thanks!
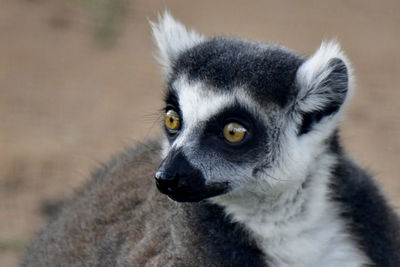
[330,137,400,267]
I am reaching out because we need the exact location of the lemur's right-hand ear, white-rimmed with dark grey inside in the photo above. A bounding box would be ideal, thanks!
[296,41,352,134]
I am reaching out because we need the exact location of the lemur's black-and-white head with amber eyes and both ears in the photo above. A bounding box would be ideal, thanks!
[152,13,351,202]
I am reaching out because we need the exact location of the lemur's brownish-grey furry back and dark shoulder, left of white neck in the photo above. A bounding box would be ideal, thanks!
[22,141,265,266]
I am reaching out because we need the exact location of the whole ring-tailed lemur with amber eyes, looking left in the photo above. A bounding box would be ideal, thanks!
[22,13,400,267]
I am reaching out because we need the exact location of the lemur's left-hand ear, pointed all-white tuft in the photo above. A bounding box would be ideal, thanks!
[150,11,205,75]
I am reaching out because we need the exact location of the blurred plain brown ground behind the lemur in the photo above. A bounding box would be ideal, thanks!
[0,0,400,266]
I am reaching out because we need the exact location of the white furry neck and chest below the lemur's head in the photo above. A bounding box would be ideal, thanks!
[214,150,367,266]
